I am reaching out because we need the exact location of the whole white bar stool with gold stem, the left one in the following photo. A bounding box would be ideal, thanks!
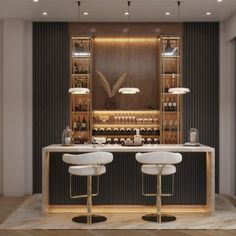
[62,152,113,224]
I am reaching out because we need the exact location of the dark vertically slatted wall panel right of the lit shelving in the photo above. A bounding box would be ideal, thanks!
[183,23,219,192]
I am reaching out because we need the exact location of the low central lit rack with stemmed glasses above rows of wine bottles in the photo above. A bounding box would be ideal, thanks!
[92,110,160,144]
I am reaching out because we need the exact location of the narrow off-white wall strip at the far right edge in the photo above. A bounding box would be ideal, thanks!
[220,14,236,195]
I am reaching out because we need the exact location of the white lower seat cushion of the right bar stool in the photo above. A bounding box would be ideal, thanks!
[141,165,176,175]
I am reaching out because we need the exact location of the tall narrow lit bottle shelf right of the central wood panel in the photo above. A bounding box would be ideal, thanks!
[161,36,182,144]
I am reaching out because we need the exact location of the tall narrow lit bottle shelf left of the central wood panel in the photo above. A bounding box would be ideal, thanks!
[70,37,92,144]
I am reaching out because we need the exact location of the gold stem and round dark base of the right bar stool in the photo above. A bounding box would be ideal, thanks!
[142,175,176,223]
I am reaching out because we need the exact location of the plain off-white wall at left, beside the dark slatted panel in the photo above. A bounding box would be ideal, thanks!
[3,19,32,196]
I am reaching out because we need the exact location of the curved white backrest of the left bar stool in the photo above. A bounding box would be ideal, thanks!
[62,152,113,165]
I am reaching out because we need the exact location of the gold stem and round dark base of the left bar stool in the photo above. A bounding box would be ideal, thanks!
[72,176,107,224]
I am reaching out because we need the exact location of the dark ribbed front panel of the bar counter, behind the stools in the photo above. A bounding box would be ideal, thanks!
[49,152,206,205]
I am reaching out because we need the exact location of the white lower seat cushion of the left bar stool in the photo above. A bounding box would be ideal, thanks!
[69,165,106,176]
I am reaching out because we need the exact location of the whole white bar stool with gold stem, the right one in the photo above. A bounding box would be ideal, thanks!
[136,152,182,223]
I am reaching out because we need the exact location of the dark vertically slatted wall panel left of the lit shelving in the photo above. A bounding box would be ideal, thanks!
[33,23,69,193]
